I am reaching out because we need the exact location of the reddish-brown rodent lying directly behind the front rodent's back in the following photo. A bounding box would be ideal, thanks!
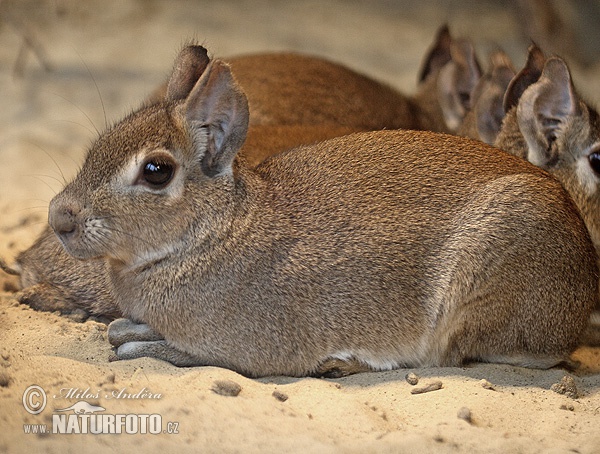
[150,25,481,137]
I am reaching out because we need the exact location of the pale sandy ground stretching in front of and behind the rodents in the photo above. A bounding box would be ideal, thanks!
[0,0,600,453]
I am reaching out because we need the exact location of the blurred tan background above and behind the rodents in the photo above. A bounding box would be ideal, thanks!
[0,0,600,248]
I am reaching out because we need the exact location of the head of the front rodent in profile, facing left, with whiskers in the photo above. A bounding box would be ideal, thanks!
[49,46,248,266]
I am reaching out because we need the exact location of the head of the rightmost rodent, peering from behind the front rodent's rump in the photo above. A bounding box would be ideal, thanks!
[495,49,600,253]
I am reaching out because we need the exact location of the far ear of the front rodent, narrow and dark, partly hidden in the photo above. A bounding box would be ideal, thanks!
[166,45,210,101]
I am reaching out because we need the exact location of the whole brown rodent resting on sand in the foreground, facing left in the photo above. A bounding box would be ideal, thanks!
[49,55,598,376]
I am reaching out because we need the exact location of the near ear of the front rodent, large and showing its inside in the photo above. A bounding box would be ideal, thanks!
[184,60,249,176]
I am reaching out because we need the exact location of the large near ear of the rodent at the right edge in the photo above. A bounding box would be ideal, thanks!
[517,57,581,169]
